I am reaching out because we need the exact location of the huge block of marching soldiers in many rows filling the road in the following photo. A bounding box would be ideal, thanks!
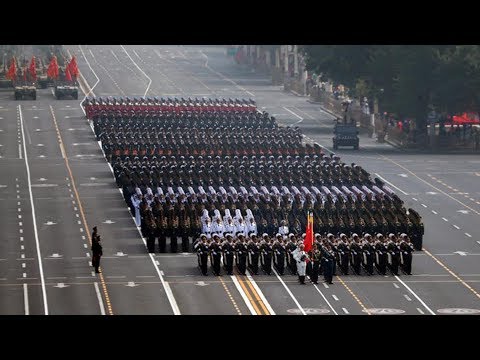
[83,97,423,274]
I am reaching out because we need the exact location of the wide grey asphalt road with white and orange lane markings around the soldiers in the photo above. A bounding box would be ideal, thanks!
[0,45,480,315]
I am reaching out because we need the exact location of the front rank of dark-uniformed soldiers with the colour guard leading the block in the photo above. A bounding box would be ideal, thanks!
[194,233,414,284]
